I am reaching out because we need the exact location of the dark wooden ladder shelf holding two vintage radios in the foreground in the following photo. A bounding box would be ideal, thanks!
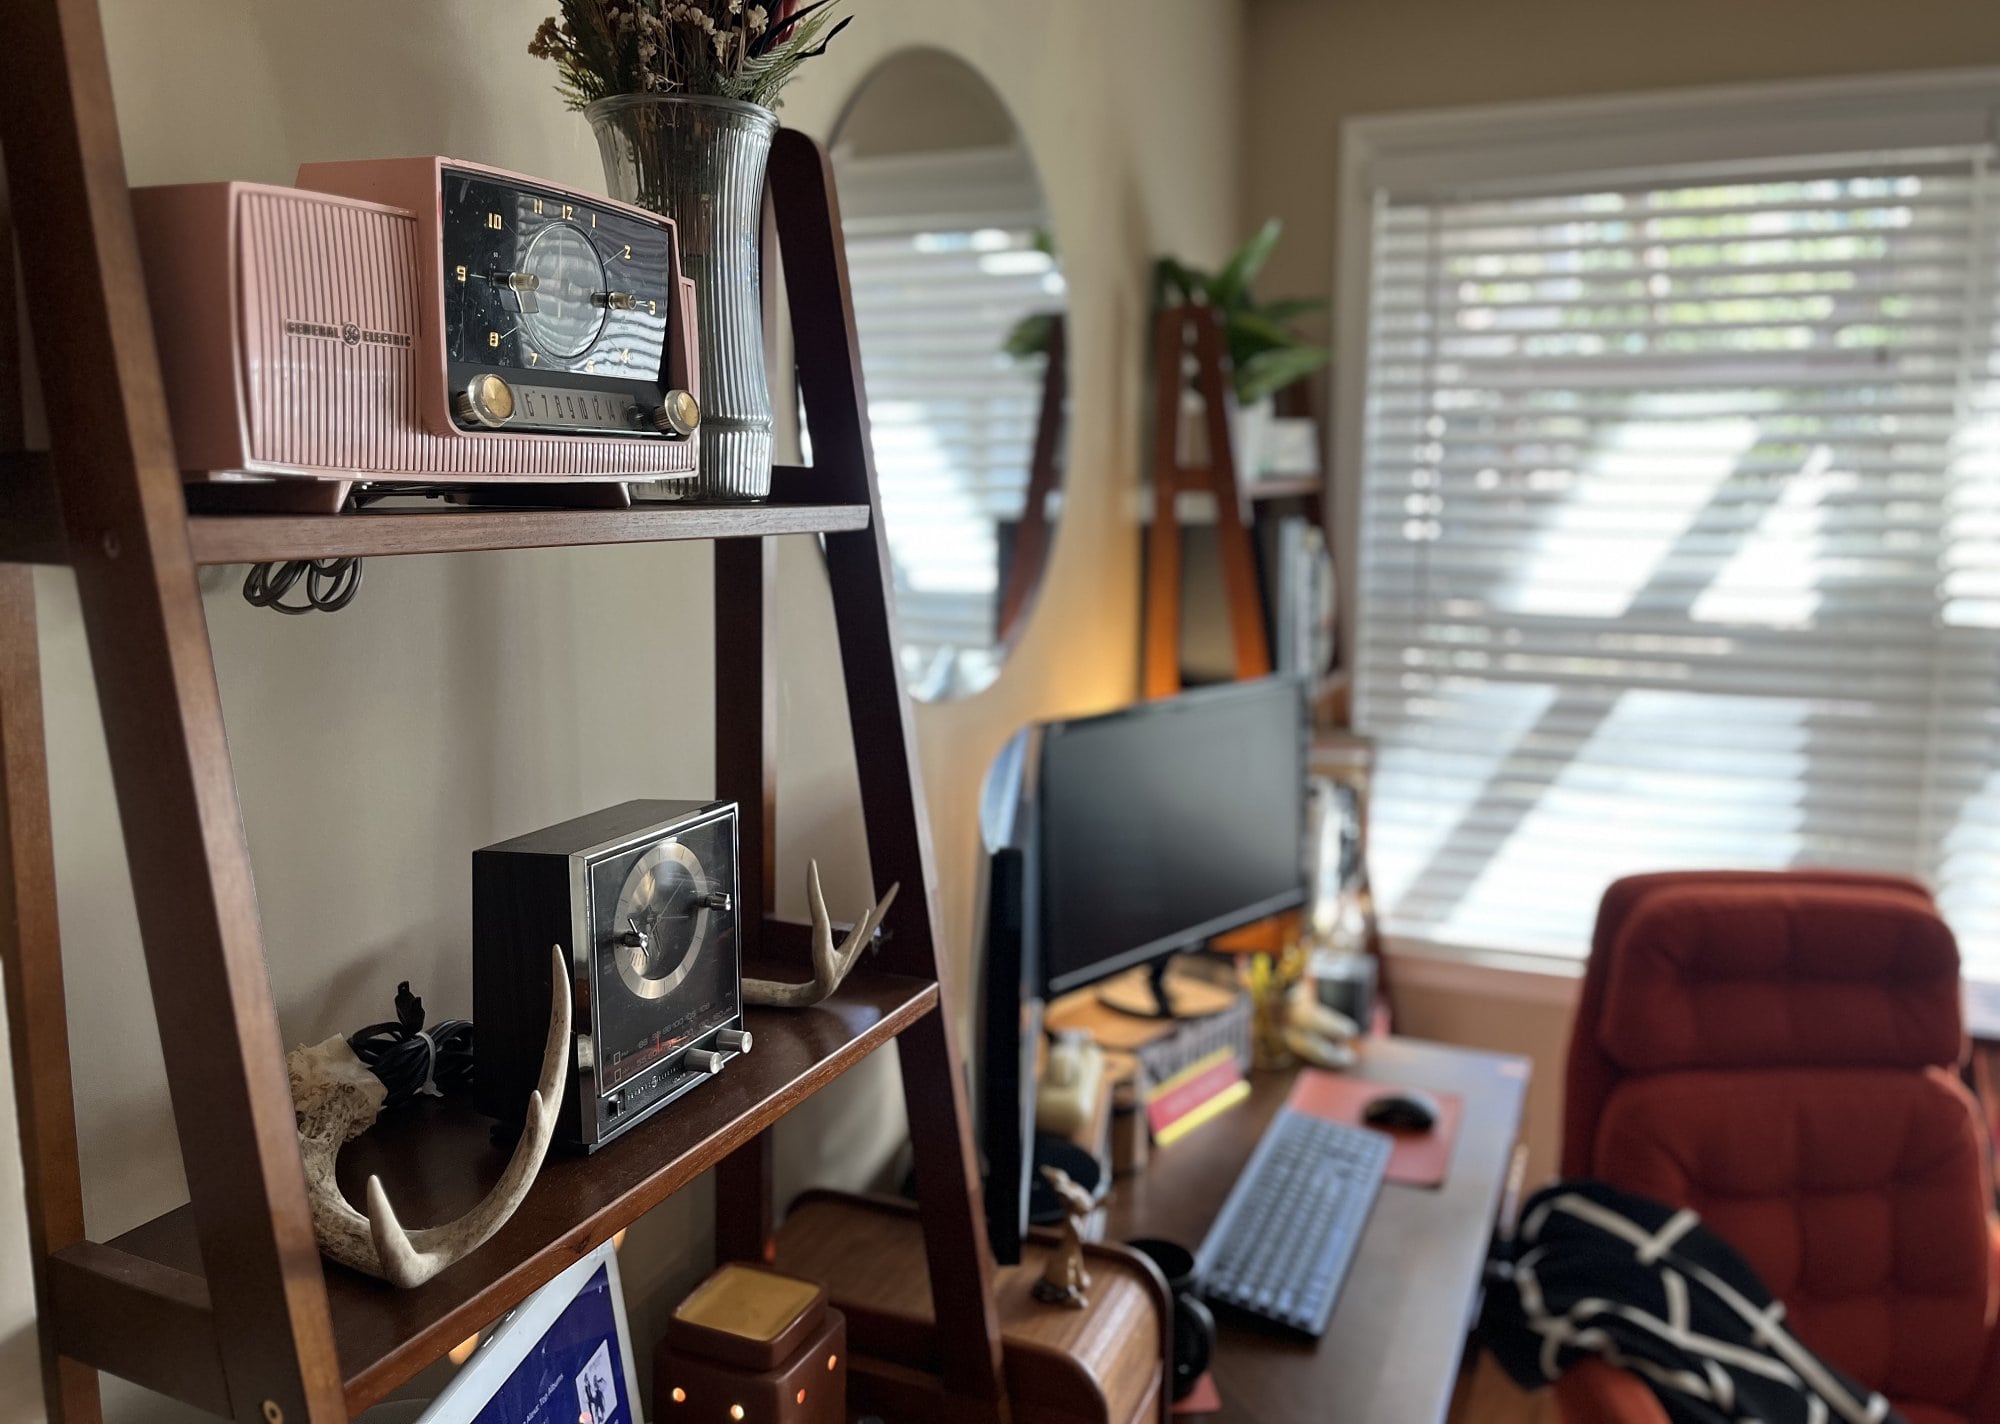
[0,0,1006,1424]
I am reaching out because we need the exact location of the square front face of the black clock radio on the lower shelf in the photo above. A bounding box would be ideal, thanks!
[590,818,738,1092]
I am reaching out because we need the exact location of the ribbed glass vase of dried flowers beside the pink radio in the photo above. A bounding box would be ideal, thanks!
[528,0,846,500]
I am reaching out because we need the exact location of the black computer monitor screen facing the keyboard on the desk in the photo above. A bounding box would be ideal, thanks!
[1034,678,1308,994]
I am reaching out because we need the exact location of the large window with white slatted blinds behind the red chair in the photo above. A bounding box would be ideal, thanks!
[1356,152,2000,980]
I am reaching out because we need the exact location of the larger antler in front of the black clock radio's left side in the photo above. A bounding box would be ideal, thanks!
[288,946,570,1290]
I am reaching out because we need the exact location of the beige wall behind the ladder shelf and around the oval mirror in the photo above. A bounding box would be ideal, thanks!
[0,0,1242,1424]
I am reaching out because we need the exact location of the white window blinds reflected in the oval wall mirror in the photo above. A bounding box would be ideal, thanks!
[842,148,1064,696]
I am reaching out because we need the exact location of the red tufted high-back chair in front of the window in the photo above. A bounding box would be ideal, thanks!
[1556,874,2000,1424]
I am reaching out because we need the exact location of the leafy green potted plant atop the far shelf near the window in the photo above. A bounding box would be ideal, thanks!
[1152,218,1332,482]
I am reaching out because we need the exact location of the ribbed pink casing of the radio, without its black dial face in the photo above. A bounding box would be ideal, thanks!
[132,158,698,508]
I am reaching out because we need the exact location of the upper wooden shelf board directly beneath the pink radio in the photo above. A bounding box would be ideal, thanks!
[188,504,868,564]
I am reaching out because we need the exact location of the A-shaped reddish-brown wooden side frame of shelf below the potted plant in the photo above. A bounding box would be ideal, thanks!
[1142,304,1270,698]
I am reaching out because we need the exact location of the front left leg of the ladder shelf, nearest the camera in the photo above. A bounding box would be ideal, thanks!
[0,0,346,1424]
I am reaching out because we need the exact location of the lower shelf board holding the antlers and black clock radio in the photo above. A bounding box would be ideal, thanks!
[108,968,938,1414]
